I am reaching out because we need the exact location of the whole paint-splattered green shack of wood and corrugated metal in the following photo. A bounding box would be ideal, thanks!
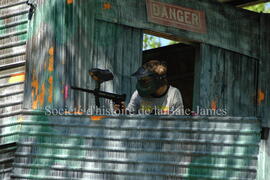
[0,0,270,180]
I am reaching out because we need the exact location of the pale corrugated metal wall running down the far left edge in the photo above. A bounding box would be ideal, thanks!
[0,0,29,180]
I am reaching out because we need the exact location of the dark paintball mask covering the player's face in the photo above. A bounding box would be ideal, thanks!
[132,67,166,97]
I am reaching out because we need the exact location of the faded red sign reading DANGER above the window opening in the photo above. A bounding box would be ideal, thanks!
[146,0,206,33]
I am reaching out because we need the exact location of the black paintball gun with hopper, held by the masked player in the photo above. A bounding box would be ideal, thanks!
[71,68,126,108]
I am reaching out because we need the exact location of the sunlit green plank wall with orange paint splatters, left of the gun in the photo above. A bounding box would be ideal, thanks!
[24,0,95,109]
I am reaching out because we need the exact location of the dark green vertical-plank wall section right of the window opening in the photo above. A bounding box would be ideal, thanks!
[195,44,258,116]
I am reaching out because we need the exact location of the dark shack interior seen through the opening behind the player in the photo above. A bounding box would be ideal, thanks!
[143,43,196,109]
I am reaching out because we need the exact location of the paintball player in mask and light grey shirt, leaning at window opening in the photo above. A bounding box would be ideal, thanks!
[114,60,184,115]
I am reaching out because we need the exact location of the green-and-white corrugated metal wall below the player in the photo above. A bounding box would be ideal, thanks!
[12,113,260,180]
